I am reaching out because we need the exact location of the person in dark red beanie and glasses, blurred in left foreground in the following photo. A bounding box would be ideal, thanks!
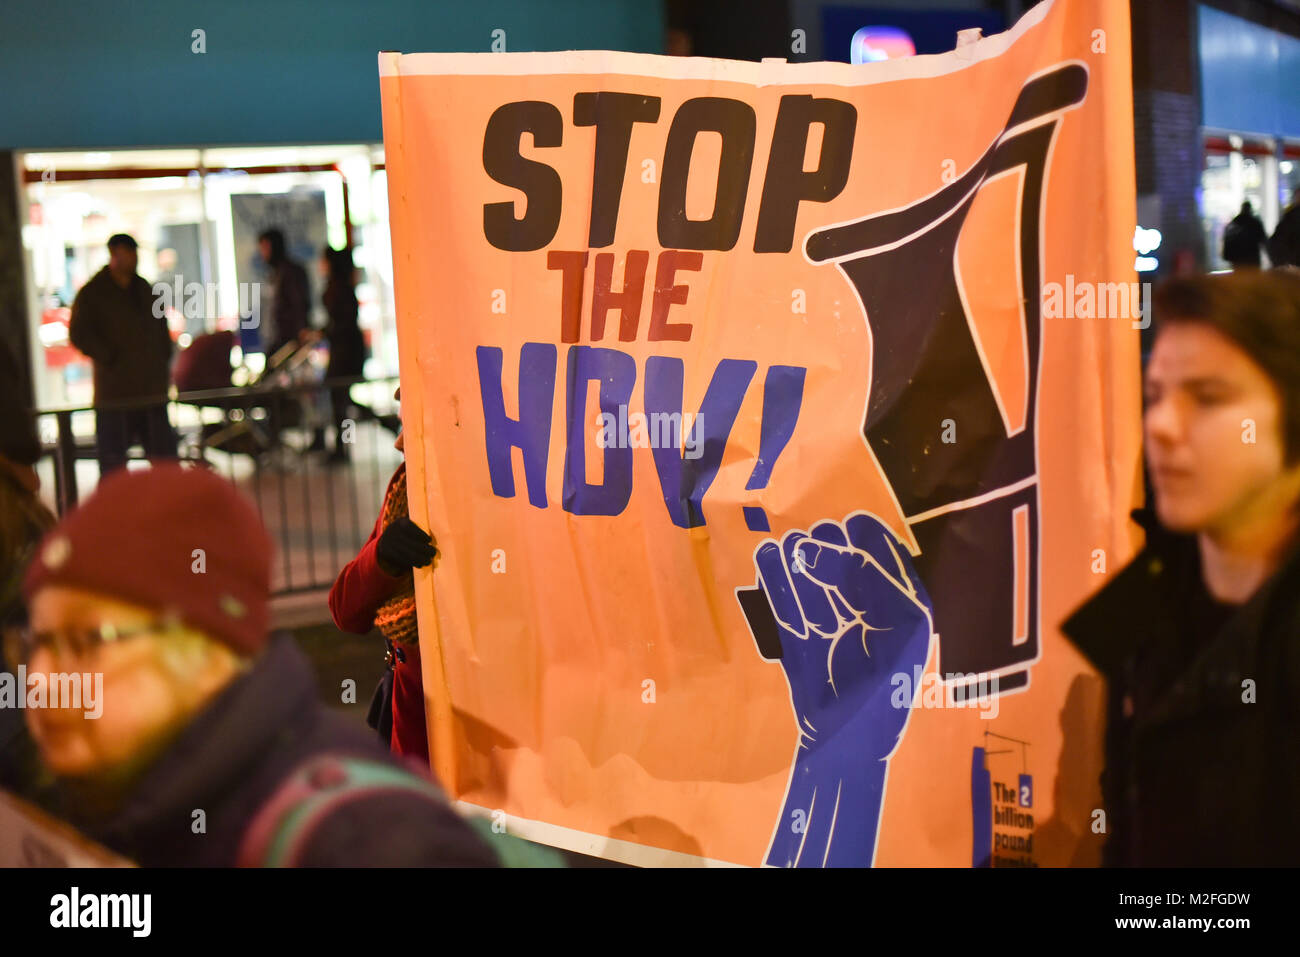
[22,464,499,866]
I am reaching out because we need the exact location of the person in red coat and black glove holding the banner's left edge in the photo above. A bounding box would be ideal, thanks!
[329,421,437,763]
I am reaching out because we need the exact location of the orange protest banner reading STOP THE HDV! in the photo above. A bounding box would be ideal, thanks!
[380,0,1147,866]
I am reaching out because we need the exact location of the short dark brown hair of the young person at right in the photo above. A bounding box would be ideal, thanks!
[1152,267,1300,465]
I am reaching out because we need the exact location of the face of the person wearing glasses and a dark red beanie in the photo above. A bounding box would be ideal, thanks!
[20,585,241,776]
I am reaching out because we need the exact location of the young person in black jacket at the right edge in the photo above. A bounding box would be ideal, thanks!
[1063,269,1300,867]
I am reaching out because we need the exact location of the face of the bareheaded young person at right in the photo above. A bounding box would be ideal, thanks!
[1144,322,1296,534]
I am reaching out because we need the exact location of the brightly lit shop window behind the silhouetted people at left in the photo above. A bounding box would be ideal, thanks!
[22,144,397,408]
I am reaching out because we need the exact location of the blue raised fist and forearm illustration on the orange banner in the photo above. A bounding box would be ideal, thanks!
[740,512,932,867]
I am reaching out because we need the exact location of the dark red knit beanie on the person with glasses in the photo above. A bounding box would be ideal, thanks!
[23,463,272,655]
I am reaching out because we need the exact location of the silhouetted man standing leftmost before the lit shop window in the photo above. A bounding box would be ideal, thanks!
[68,233,176,475]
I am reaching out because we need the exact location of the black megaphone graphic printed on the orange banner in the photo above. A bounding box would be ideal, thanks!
[741,64,1088,700]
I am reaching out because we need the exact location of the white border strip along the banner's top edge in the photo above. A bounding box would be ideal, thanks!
[380,0,1056,86]
